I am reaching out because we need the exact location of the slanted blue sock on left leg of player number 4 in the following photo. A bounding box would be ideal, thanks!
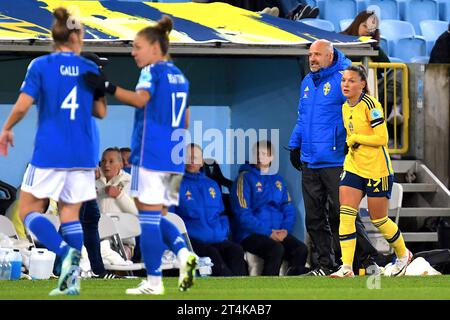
[23,212,69,257]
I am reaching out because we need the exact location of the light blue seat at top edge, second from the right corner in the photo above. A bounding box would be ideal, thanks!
[404,0,439,34]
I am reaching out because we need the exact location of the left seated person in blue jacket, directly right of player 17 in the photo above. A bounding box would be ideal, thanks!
[175,144,247,276]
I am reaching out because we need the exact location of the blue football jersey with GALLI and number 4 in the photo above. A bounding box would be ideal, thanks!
[20,52,99,169]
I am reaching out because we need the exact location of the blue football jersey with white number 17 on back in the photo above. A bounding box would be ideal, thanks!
[130,61,189,173]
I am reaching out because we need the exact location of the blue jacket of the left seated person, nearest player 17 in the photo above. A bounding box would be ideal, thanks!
[175,172,230,243]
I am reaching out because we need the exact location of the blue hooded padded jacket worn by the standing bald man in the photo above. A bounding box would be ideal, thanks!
[289,49,351,169]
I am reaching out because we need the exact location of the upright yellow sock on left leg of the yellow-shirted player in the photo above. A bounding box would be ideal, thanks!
[339,206,358,267]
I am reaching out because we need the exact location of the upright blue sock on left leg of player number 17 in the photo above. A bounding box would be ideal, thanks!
[139,210,165,276]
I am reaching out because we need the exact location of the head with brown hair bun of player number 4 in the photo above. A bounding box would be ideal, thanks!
[52,7,82,44]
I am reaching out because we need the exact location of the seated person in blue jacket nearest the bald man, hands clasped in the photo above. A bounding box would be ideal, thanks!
[230,141,308,276]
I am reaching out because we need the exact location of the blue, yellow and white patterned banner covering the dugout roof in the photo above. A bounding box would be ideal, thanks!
[0,0,368,45]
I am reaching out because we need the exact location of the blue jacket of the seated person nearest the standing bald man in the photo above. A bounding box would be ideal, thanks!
[230,164,295,242]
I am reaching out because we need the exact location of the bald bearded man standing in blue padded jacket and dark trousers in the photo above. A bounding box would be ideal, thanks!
[289,40,377,276]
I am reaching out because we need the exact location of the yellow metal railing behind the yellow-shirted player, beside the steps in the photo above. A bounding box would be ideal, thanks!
[358,62,409,154]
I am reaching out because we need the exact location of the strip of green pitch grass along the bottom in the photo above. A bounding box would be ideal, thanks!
[0,276,450,300]
